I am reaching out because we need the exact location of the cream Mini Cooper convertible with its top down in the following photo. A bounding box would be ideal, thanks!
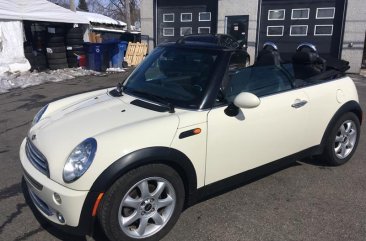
[20,35,362,240]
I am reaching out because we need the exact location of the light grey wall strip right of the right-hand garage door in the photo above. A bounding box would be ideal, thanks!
[342,0,366,73]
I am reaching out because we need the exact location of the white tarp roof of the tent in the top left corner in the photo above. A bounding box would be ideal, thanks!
[0,0,89,24]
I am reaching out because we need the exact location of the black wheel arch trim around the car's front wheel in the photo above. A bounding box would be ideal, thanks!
[77,147,197,234]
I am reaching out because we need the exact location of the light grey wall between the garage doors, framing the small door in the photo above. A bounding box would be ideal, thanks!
[217,0,258,63]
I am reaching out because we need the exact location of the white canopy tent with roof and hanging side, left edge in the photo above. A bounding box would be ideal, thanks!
[0,0,89,75]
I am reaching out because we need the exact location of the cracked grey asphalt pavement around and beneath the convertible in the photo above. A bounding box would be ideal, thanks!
[0,73,366,241]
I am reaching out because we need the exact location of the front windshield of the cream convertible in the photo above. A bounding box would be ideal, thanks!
[123,46,219,109]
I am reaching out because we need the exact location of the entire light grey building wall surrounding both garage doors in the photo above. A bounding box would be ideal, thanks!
[141,0,366,73]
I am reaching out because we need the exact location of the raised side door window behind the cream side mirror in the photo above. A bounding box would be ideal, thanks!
[222,58,292,102]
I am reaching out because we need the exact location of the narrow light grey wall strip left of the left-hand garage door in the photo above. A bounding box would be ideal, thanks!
[141,0,155,52]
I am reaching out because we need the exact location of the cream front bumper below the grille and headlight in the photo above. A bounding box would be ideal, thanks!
[19,139,94,228]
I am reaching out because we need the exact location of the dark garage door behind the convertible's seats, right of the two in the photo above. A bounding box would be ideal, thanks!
[258,0,346,60]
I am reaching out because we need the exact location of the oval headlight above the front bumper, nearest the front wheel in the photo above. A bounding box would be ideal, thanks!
[63,138,97,183]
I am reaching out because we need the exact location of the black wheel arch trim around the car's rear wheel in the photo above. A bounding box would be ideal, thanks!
[321,100,363,147]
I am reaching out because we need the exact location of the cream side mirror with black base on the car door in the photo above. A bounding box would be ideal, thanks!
[225,92,261,117]
